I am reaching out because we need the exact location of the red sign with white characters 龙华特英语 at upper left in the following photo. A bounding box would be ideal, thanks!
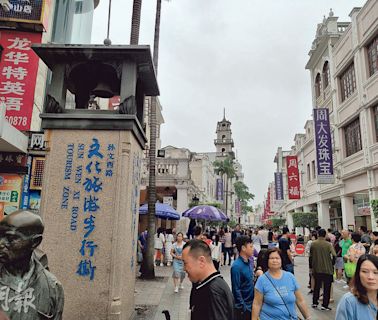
[0,30,42,130]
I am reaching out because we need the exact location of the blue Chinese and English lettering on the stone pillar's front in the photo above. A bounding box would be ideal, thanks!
[60,137,116,280]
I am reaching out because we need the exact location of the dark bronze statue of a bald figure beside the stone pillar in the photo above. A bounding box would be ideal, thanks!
[0,210,64,320]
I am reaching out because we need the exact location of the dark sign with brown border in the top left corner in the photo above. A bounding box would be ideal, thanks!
[0,0,46,24]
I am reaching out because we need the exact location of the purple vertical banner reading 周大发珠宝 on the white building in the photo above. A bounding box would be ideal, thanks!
[314,108,335,184]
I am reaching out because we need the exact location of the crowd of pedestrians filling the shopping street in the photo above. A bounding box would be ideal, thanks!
[138,225,378,320]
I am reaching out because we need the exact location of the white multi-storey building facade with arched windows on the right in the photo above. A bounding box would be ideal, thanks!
[274,0,378,230]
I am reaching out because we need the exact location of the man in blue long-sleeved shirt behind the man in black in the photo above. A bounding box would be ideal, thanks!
[231,236,253,320]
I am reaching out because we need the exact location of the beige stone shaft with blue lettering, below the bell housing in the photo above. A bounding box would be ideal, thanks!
[41,126,142,320]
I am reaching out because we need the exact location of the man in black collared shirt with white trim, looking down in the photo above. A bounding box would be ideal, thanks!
[182,239,234,320]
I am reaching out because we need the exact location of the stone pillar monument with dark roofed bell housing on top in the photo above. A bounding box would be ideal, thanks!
[33,44,159,320]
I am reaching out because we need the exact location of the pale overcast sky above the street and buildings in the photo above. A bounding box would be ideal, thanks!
[92,0,366,205]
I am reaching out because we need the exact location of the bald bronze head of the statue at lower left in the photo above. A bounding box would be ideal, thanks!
[0,210,44,265]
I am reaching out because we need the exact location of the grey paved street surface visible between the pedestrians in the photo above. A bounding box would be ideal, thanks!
[134,257,347,320]
